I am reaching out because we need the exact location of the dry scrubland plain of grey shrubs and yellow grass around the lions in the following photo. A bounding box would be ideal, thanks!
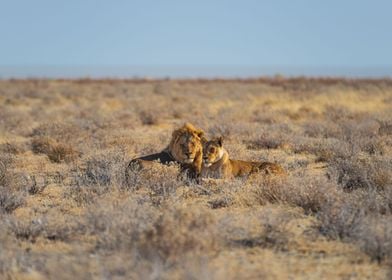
[0,77,392,279]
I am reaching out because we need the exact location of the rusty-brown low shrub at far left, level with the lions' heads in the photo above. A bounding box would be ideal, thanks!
[32,137,80,163]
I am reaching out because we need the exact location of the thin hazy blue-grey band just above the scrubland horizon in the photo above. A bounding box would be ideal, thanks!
[0,65,392,79]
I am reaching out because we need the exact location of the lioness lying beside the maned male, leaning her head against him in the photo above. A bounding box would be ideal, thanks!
[202,137,285,179]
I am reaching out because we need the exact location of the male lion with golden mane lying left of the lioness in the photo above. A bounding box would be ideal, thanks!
[127,123,204,178]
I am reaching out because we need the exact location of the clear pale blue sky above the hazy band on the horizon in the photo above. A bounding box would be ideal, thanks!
[0,0,392,76]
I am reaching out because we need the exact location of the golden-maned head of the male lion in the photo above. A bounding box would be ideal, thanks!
[169,123,204,164]
